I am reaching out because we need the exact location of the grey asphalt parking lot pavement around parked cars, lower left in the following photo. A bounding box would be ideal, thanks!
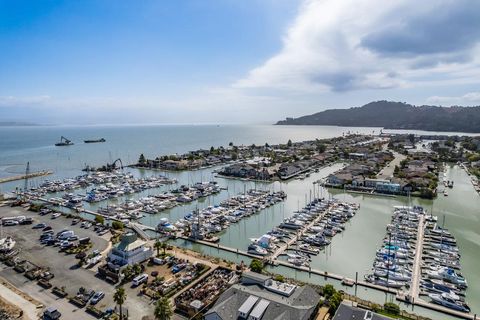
[0,207,153,320]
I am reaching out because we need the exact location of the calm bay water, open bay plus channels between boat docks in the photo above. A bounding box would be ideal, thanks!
[0,125,480,319]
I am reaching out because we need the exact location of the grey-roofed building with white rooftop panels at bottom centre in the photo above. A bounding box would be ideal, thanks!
[205,272,320,320]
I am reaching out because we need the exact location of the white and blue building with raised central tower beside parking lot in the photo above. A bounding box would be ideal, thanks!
[108,232,153,266]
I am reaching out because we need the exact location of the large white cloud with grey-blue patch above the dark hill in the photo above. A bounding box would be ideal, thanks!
[233,0,480,92]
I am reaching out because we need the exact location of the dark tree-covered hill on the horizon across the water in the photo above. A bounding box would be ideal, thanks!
[277,101,480,133]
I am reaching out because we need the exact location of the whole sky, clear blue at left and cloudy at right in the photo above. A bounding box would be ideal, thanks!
[0,0,480,124]
